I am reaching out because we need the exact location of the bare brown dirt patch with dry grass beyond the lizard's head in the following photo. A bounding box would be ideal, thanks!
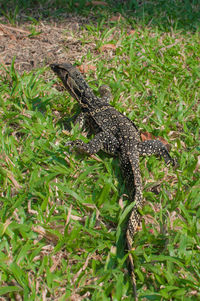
[0,16,95,74]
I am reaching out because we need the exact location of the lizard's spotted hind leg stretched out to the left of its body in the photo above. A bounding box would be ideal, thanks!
[65,132,119,155]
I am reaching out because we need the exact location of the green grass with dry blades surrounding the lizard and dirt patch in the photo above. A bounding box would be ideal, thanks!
[0,0,200,301]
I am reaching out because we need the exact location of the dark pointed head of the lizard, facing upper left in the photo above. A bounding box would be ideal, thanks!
[50,63,87,102]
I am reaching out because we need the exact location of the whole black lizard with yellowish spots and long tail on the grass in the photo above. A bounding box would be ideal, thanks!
[50,63,174,300]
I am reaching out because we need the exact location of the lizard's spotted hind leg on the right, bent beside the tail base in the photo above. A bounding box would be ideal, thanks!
[134,140,175,166]
